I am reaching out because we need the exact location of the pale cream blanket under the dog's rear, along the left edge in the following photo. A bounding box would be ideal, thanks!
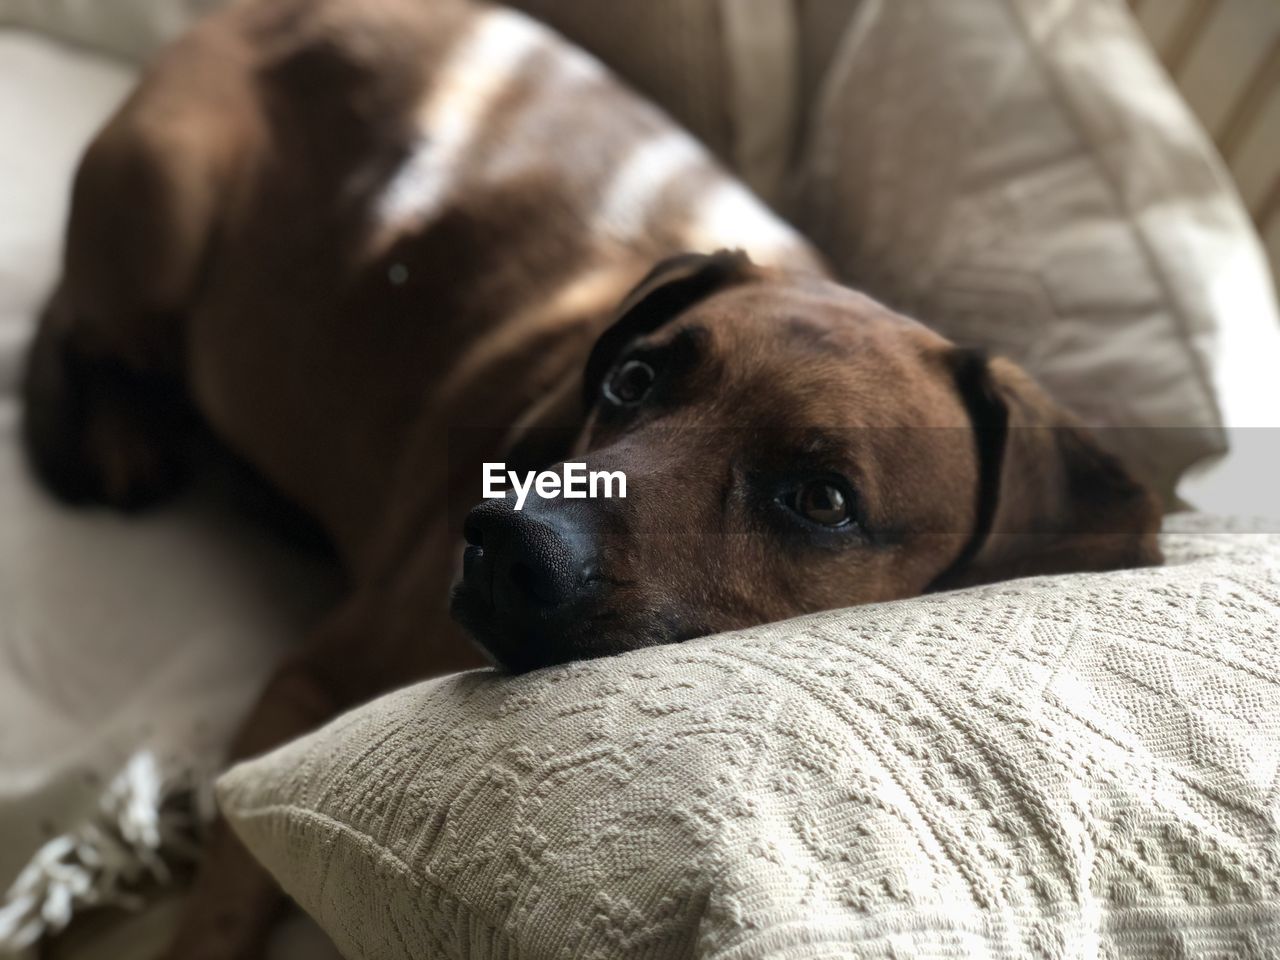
[0,32,343,960]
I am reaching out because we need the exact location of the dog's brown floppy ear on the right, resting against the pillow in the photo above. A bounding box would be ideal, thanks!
[933,351,1161,590]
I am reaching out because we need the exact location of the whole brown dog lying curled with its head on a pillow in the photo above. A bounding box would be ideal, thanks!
[26,0,1158,960]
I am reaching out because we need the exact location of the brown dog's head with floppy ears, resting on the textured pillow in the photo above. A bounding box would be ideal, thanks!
[453,252,1160,669]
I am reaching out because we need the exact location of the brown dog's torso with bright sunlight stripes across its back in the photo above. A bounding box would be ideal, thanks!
[49,0,818,563]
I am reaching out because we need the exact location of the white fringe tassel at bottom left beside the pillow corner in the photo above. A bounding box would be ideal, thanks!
[0,753,214,956]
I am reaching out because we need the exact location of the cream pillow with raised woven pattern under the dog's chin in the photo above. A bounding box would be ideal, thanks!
[219,527,1280,960]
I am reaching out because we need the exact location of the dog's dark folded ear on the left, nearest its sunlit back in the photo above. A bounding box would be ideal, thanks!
[582,250,755,407]
